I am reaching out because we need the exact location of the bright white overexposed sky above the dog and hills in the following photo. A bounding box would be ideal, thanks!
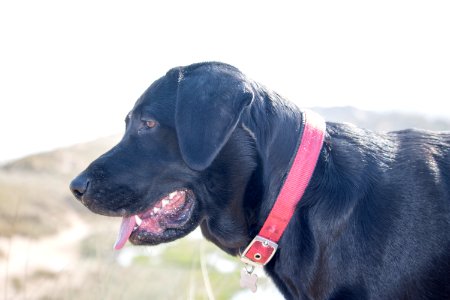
[0,0,450,161]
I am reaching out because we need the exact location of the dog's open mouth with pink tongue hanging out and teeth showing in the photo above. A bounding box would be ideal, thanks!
[114,189,194,250]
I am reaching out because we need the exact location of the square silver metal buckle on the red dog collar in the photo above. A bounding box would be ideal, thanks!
[241,235,278,267]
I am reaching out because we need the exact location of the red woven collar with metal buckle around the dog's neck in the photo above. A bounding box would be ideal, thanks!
[241,111,325,266]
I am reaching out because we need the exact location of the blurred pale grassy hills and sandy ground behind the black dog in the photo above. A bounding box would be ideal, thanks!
[0,108,450,300]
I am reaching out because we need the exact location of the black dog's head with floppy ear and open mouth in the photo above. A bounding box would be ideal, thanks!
[70,63,257,254]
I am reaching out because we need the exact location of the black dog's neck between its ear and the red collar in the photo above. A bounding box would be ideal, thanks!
[242,87,310,223]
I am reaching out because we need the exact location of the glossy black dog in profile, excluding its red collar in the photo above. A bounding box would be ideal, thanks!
[71,63,450,299]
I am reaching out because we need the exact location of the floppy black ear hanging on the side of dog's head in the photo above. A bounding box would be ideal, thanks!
[175,64,253,171]
